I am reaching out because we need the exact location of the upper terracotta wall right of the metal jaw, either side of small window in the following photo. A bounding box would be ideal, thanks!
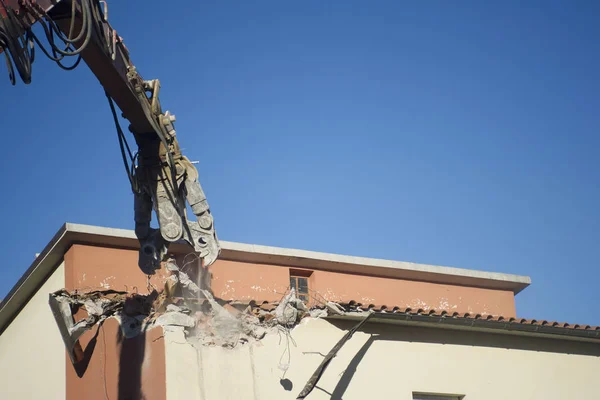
[211,260,516,317]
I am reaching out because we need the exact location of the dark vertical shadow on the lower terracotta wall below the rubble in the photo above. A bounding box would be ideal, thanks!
[117,329,146,400]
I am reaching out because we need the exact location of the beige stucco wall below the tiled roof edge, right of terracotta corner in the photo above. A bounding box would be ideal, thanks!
[166,320,600,400]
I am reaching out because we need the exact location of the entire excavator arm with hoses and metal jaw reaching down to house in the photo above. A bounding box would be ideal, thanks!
[0,0,220,275]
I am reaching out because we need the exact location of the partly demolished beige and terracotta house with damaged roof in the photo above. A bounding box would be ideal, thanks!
[0,224,600,400]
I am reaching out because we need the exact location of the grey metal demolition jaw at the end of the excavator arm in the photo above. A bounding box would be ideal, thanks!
[130,76,221,275]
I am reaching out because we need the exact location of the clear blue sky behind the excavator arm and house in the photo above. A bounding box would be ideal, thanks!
[0,0,600,325]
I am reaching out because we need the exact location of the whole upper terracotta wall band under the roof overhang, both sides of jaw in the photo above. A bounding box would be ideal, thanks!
[65,245,516,317]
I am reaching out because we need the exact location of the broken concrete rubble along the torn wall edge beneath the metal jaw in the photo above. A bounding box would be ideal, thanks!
[50,260,345,363]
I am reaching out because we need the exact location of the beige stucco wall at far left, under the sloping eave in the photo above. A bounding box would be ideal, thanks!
[0,264,66,400]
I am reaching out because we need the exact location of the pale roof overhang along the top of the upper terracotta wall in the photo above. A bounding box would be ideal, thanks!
[0,223,531,333]
